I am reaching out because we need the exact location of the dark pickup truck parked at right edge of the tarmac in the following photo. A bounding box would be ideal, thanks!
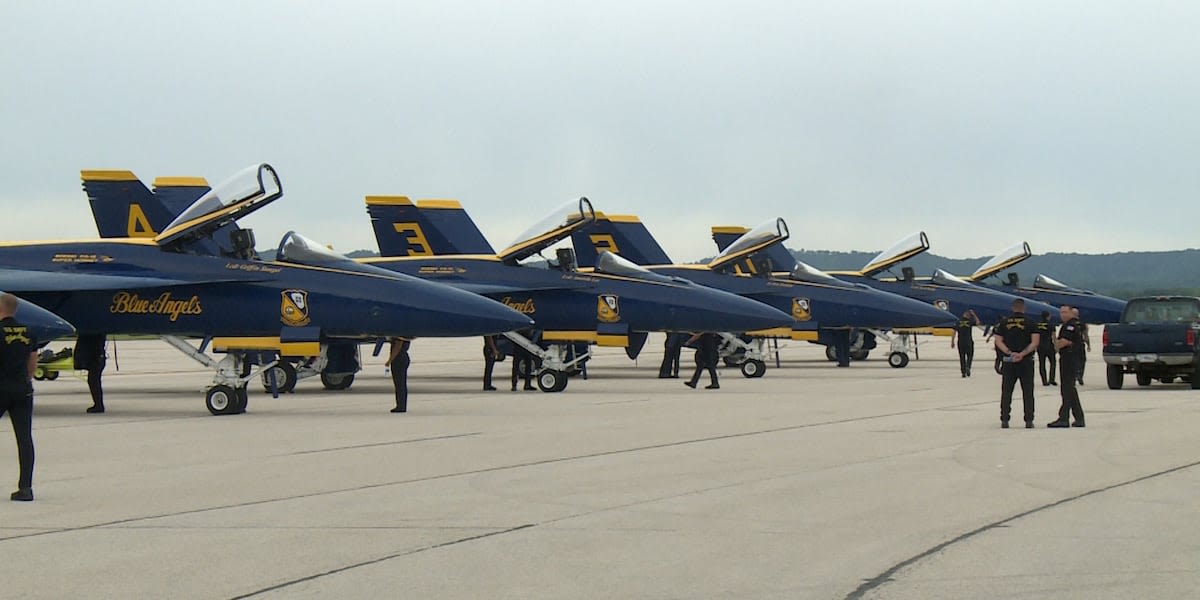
[1104,296,1200,390]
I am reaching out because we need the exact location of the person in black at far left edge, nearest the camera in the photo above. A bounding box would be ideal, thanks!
[0,294,37,502]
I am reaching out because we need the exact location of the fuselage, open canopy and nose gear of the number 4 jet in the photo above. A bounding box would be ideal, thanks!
[0,164,530,414]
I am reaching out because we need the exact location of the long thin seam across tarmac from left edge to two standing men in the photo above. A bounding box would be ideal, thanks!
[0,401,992,544]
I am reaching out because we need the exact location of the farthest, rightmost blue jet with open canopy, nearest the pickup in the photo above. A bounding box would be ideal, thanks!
[962,241,1126,325]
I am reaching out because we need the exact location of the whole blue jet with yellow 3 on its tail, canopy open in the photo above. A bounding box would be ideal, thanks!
[364,197,792,391]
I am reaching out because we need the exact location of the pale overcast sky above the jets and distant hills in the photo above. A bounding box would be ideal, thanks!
[0,0,1200,260]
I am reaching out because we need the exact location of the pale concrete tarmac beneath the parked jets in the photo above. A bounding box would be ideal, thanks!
[0,330,1200,599]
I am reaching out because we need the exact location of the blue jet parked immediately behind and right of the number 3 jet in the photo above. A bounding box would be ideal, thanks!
[561,215,954,369]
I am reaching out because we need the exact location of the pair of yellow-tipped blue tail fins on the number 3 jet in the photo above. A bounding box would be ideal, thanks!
[366,196,496,257]
